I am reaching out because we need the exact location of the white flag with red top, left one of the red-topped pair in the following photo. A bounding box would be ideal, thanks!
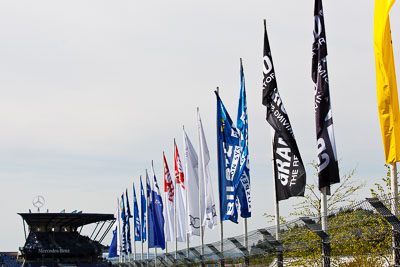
[163,153,175,241]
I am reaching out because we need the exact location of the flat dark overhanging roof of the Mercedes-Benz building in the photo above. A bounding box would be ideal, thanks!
[18,213,114,227]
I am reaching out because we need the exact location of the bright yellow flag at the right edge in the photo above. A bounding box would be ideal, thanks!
[374,0,400,163]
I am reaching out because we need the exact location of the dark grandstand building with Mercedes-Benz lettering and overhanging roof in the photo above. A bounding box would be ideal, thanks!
[19,213,114,267]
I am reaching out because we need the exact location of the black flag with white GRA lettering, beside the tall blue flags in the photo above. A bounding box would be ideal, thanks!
[262,20,306,201]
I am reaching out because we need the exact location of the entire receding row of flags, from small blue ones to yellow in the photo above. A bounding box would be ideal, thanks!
[109,0,400,257]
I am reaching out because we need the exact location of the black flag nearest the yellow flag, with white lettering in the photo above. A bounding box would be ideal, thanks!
[311,0,340,194]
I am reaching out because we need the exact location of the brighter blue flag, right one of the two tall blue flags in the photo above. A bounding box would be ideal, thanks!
[236,59,251,218]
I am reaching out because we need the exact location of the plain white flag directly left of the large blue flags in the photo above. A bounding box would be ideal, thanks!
[197,109,217,229]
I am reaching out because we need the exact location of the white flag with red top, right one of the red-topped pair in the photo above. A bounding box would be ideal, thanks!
[174,139,186,242]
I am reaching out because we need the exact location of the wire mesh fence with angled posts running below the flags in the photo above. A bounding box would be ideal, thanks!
[118,197,400,267]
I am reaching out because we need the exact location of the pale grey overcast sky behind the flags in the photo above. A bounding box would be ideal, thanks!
[0,0,400,251]
